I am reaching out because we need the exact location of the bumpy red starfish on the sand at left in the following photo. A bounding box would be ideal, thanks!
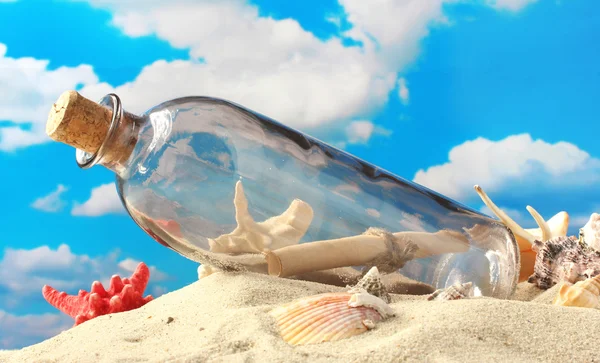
[42,262,153,326]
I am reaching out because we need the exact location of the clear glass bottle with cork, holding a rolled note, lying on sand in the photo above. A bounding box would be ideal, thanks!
[46,91,519,298]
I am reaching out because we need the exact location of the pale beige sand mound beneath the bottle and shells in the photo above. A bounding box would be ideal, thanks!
[0,272,600,363]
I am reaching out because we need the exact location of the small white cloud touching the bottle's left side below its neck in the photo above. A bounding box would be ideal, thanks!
[71,183,125,217]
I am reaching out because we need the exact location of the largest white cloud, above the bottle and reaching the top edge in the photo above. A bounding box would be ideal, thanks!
[72,0,460,132]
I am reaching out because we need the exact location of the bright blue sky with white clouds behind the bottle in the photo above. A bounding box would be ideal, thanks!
[0,0,600,349]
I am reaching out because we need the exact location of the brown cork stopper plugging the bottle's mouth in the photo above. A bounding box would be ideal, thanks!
[46,91,112,154]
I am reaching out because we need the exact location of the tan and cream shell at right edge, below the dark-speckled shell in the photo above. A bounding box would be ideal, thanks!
[552,275,600,308]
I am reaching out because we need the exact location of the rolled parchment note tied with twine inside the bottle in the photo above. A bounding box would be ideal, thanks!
[265,229,469,277]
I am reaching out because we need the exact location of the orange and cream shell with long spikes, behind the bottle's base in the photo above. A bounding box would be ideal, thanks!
[474,185,569,282]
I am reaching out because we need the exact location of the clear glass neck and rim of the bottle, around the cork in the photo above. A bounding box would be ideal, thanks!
[76,94,143,175]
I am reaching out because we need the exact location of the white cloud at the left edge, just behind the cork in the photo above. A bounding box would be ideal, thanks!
[0,43,98,151]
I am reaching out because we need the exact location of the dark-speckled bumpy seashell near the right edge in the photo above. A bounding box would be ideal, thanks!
[527,236,600,289]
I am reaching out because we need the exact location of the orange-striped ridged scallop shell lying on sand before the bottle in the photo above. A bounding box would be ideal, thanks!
[270,290,394,345]
